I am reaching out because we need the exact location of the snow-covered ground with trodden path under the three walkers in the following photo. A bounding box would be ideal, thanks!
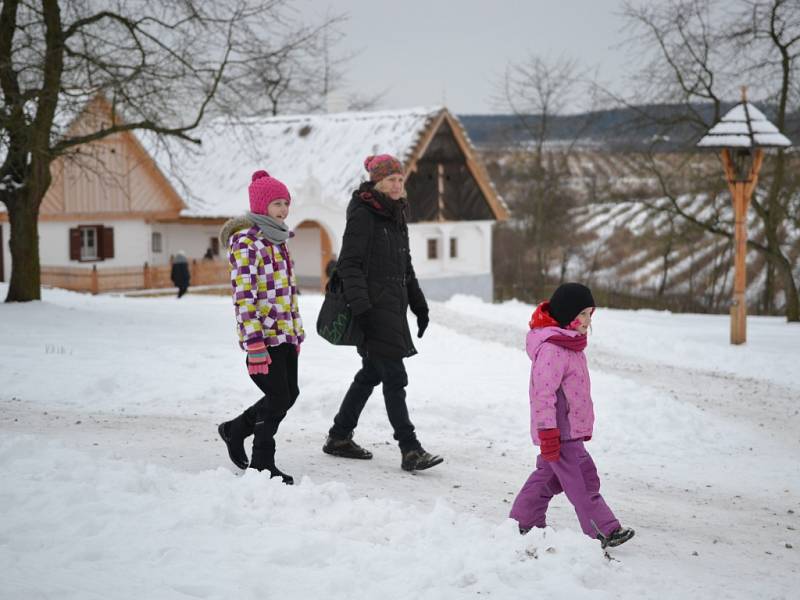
[0,284,800,600]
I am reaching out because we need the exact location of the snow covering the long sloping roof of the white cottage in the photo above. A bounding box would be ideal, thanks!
[154,107,443,217]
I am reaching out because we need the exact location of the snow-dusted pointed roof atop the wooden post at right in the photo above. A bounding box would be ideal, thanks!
[697,102,792,148]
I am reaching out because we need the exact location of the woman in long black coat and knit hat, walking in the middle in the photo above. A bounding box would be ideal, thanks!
[322,154,443,471]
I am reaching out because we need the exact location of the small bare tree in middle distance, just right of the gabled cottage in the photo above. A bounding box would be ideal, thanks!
[496,55,592,296]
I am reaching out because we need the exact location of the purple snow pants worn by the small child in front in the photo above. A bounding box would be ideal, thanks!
[509,440,620,539]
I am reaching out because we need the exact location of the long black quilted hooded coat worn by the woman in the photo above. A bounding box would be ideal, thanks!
[337,182,428,359]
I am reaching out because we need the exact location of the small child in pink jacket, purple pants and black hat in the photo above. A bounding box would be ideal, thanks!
[510,283,634,548]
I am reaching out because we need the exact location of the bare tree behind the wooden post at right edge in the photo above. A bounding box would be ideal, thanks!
[625,0,800,321]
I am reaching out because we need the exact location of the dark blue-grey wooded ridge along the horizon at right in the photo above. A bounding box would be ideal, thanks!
[458,103,800,150]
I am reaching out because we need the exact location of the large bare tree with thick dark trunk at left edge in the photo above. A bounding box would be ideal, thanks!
[0,0,344,301]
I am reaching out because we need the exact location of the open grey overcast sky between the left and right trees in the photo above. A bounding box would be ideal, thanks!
[296,0,628,114]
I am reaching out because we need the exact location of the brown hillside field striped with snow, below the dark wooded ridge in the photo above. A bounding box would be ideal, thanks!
[480,146,800,314]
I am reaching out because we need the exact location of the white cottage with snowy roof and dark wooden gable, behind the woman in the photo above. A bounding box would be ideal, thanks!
[175,108,507,300]
